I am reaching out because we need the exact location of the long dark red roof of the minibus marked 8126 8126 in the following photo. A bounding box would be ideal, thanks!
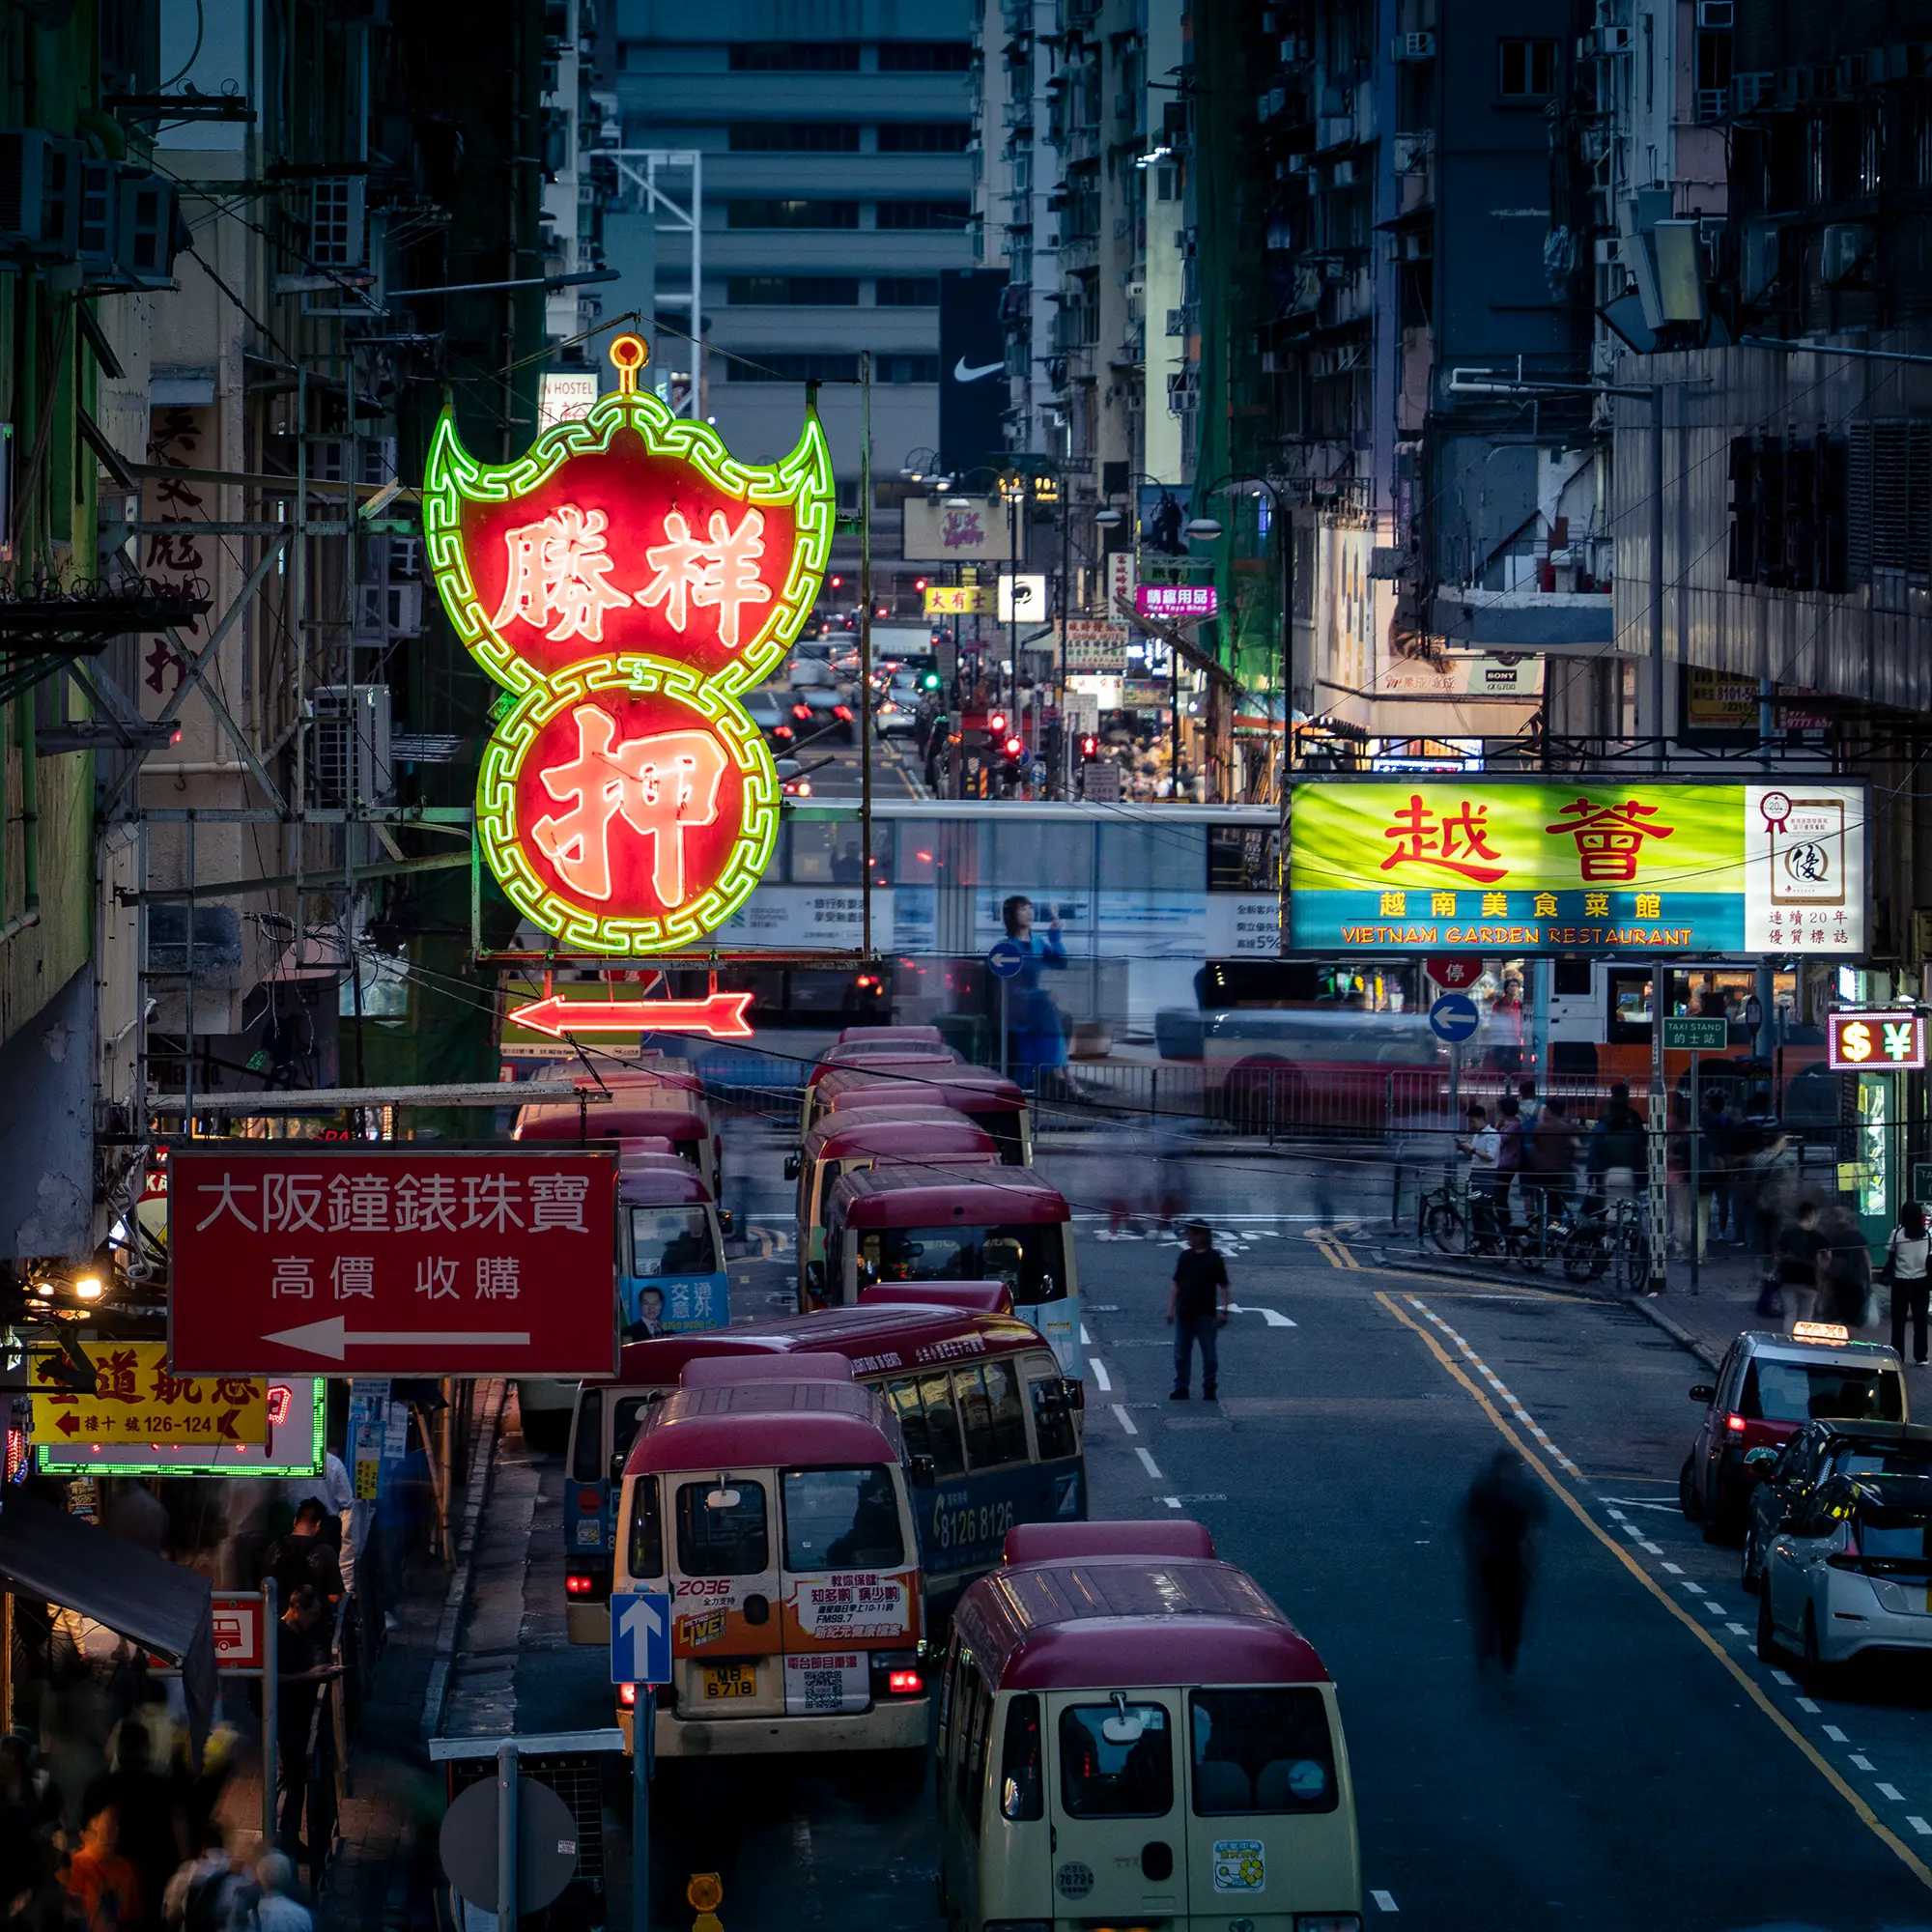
[607,1302,1047,1389]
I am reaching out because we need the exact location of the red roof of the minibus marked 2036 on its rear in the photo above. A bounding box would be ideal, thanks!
[624,1381,900,1476]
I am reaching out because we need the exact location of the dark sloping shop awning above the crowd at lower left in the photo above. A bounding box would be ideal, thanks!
[0,1486,214,1760]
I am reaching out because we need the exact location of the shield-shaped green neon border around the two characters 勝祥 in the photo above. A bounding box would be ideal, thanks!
[423,392,835,696]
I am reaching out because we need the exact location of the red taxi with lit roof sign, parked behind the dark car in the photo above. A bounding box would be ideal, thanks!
[1677,1321,1909,1542]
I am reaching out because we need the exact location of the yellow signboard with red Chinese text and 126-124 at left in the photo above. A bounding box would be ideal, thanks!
[27,1341,269,1449]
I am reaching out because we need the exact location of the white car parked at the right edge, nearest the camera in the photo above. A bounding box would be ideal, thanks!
[1758,1474,1932,1683]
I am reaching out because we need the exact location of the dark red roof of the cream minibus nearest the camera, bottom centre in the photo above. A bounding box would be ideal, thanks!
[952,1557,1327,1690]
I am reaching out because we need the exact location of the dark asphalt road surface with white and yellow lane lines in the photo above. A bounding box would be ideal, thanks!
[448,1142,1932,1932]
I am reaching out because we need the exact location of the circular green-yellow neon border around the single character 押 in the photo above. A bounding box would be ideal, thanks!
[477,653,779,958]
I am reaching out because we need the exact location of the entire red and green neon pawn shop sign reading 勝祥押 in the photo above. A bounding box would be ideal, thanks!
[423,336,833,958]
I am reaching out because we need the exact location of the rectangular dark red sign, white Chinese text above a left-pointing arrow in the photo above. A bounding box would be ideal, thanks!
[168,1142,616,1379]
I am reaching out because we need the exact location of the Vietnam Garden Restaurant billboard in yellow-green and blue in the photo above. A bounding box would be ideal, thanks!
[1285,777,1868,960]
